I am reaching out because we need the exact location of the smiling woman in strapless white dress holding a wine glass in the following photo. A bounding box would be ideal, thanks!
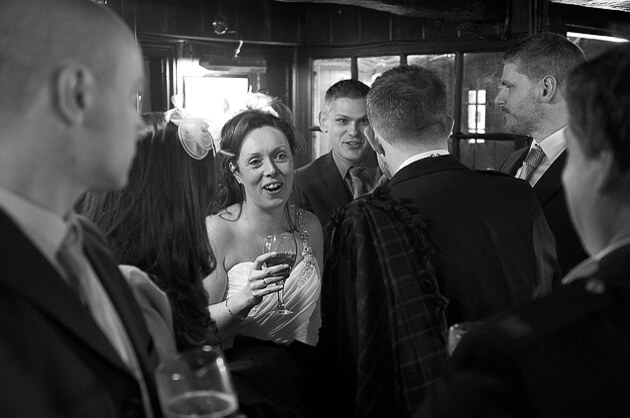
[204,110,323,416]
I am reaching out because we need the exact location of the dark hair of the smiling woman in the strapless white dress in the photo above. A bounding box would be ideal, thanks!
[212,110,301,229]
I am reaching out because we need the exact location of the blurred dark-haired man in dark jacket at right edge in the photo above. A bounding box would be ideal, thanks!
[417,45,630,417]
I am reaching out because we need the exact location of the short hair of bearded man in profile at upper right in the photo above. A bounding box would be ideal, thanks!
[501,33,586,93]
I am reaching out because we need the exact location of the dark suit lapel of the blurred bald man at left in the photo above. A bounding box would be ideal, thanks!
[0,211,128,371]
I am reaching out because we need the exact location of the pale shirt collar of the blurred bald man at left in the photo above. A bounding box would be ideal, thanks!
[0,186,66,264]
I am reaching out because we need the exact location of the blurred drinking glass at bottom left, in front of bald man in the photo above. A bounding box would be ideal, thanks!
[155,345,238,418]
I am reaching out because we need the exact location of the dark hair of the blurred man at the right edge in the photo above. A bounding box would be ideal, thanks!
[567,44,630,171]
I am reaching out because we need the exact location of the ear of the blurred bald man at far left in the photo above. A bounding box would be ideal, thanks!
[55,64,96,125]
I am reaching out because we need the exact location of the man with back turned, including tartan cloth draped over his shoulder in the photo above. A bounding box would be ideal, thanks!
[318,66,556,416]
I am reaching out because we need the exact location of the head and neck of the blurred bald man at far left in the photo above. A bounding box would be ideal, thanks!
[0,0,144,198]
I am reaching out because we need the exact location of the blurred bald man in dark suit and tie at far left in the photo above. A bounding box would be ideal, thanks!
[0,0,161,417]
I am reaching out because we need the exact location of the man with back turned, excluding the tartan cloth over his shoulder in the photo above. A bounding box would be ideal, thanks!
[366,66,556,324]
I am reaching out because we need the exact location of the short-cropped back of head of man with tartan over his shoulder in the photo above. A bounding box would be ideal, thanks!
[367,65,452,150]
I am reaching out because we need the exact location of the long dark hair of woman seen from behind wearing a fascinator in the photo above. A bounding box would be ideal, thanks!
[79,113,216,350]
